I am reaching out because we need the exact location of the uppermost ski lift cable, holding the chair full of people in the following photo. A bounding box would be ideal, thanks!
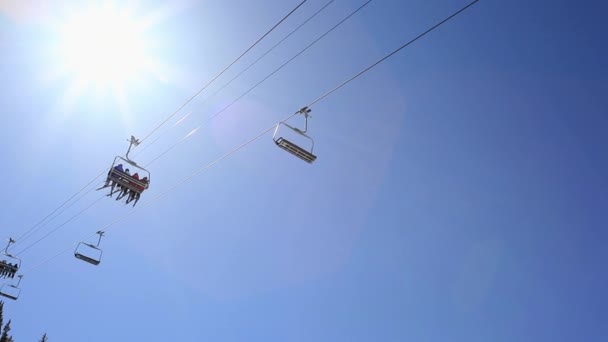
[4,0,308,243]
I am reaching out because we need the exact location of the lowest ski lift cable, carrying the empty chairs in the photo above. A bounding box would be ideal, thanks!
[20,0,480,272]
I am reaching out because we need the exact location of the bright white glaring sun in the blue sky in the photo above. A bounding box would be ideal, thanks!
[58,7,159,91]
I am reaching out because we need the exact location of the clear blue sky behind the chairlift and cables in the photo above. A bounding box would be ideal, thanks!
[0,0,608,342]
